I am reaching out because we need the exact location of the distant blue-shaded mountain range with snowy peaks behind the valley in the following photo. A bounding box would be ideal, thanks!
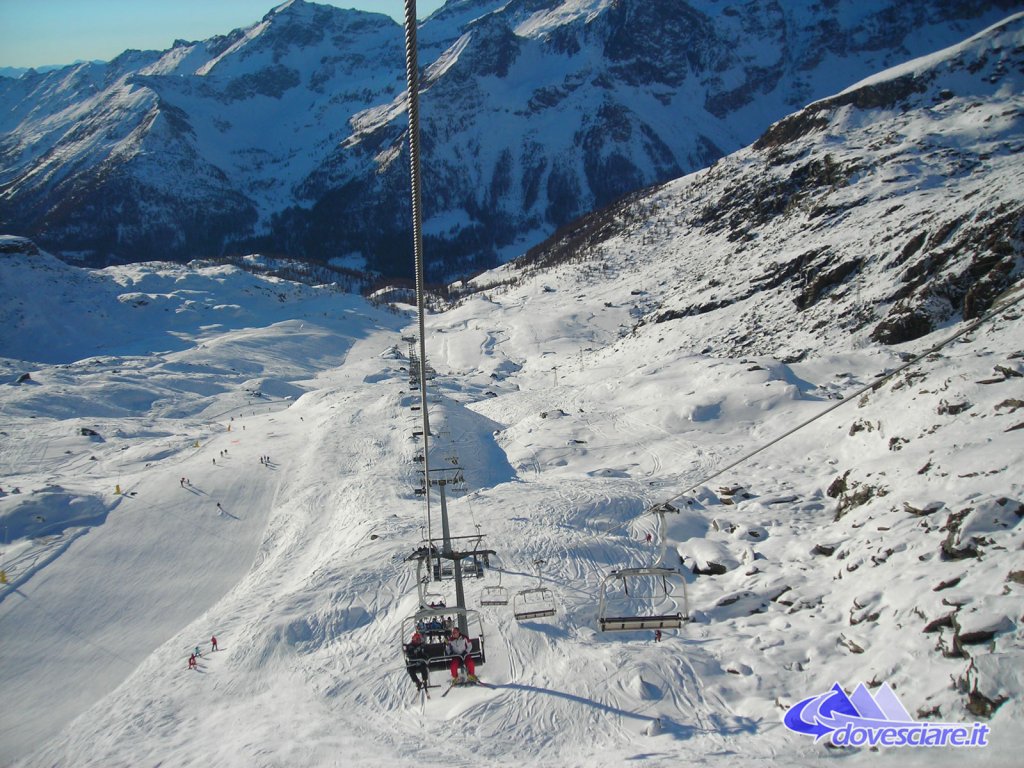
[0,0,1016,279]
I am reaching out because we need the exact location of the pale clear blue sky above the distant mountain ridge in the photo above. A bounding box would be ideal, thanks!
[0,0,443,67]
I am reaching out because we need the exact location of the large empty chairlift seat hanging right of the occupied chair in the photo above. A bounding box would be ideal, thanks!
[597,504,689,632]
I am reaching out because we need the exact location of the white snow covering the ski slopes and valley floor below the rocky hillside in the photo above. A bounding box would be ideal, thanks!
[0,225,1024,766]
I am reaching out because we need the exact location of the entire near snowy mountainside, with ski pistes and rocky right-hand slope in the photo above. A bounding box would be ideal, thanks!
[0,15,1024,768]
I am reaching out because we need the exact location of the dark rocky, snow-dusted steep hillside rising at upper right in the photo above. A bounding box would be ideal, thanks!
[522,14,1024,354]
